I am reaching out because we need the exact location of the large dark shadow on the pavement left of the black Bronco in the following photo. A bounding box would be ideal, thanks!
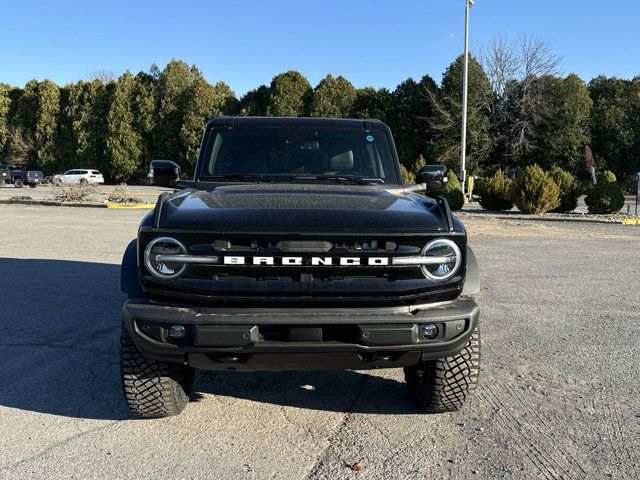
[0,258,129,420]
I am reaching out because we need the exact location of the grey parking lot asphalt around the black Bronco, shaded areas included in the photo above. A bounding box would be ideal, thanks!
[0,205,640,480]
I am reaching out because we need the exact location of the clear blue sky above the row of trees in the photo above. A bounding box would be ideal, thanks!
[0,0,640,95]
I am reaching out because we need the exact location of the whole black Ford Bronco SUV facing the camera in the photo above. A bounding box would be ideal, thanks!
[120,117,480,418]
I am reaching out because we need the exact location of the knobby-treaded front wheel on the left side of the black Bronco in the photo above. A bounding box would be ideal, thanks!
[120,322,194,418]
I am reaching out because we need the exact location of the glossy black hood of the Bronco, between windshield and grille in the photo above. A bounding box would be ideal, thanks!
[156,184,448,233]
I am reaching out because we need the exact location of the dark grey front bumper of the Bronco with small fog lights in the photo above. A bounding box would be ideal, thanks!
[123,298,479,370]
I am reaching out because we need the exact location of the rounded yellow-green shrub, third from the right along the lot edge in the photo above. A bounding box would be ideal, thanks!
[513,165,560,215]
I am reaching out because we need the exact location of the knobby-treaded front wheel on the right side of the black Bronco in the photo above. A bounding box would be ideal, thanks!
[404,328,480,413]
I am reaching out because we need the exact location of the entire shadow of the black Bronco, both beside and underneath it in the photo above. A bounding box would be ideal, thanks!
[0,258,415,420]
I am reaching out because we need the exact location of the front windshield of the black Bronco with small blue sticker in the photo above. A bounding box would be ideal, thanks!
[200,126,398,184]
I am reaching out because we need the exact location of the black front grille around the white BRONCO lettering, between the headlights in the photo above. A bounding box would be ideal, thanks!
[139,231,465,306]
